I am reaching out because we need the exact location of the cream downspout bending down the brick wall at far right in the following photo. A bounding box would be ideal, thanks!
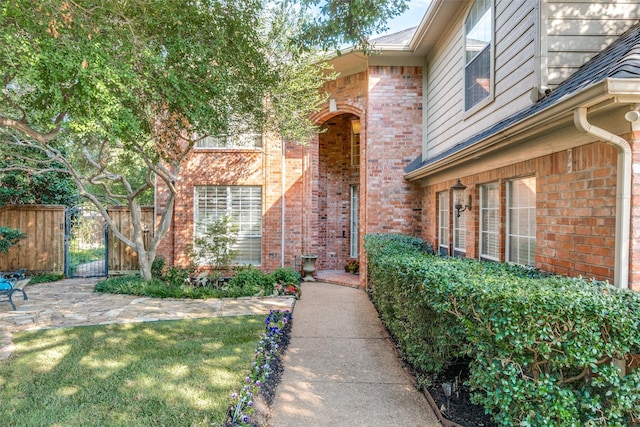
[573,107,632,289]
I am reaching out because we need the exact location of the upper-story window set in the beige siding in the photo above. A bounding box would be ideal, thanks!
[464,0,493,111]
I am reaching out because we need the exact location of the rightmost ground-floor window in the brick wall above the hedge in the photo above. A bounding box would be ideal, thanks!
[507,177,536,265]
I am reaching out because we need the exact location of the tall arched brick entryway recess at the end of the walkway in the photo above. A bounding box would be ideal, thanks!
[317,113,362,272]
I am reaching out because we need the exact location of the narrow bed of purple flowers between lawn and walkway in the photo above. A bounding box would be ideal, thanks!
[229,310,291,426]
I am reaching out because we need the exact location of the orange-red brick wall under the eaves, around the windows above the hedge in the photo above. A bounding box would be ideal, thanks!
[423,142,617,282]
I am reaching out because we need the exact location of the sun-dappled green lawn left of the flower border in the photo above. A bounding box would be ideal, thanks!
[0,316,264,426]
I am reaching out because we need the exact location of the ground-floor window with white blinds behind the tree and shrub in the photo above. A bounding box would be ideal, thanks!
[194,186,262,265]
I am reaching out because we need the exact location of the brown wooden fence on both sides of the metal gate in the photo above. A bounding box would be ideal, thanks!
[0,205,155,274]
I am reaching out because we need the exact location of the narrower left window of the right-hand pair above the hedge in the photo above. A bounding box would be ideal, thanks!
[480,182,500,261]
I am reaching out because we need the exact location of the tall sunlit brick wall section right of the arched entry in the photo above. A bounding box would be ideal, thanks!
[361,66,422,239]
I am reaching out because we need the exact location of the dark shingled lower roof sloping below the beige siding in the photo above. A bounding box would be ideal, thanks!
[405,23,640,173]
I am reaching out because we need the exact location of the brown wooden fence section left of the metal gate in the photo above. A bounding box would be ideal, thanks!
[0,205,66,274]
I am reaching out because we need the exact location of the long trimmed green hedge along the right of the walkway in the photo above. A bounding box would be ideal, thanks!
[365,235,640,426]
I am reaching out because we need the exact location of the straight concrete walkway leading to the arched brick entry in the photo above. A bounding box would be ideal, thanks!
[269,282,440,427]
